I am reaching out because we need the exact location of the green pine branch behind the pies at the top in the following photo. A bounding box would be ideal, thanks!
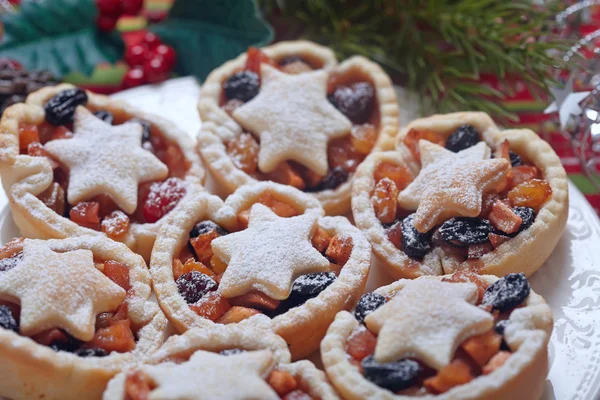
[259,0,568,122]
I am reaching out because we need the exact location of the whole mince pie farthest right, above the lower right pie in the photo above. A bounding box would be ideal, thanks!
[352,112,568,278]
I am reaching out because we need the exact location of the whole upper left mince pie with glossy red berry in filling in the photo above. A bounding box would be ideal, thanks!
[0,84,204,258]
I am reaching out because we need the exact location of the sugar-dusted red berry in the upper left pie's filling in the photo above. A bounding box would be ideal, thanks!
[142,178,186,223]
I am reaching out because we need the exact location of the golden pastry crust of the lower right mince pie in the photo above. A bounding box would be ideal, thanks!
[321,275,552,400]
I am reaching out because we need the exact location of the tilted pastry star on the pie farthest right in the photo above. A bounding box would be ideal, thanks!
[398,140,510,232]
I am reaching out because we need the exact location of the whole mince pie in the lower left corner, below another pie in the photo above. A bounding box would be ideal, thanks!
[0,235,167,400]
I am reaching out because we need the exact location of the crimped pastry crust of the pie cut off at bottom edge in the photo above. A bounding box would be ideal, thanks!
[103,324,339,400]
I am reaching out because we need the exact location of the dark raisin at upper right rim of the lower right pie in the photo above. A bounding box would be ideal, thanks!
[482,273,531,312]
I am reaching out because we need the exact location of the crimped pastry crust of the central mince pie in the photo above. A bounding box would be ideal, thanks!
[150,182,371,359]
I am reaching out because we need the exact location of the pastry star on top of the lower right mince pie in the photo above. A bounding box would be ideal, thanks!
[365,279,494,370]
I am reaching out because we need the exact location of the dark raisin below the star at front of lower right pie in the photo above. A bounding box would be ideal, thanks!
[360,355,421,392]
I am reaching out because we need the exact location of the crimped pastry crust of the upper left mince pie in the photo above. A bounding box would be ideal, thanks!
[0,84,205,259]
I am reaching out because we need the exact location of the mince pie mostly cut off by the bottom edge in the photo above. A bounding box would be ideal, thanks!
[104,318,339,400]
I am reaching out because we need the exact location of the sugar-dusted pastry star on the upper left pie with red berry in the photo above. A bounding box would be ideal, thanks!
[44,106,169,214]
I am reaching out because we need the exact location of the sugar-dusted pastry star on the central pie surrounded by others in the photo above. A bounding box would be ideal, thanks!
[212,204,329,300]
